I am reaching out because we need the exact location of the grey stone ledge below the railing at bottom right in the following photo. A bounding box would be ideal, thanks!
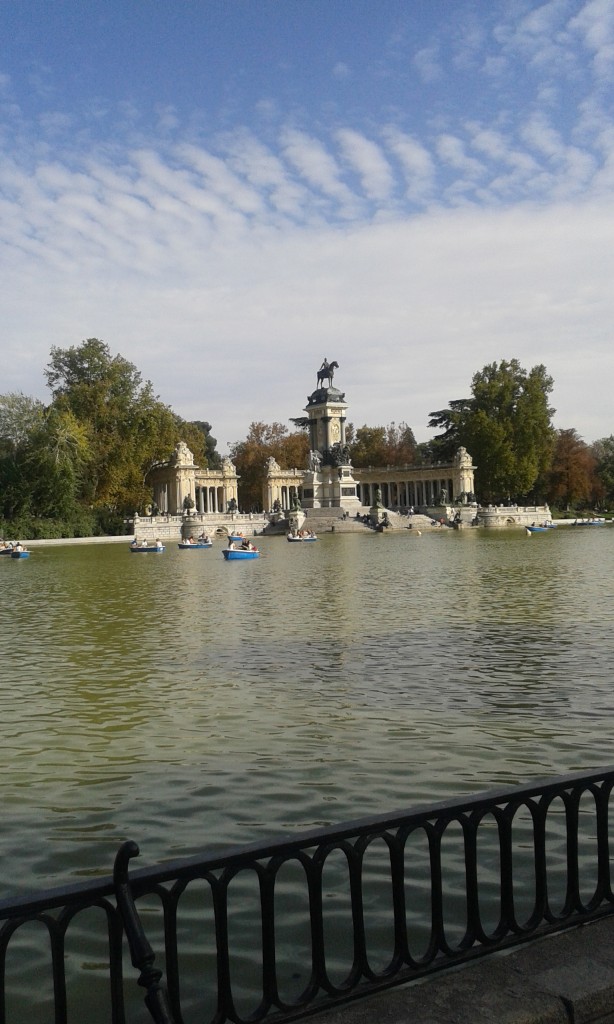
[316,918,614,1024]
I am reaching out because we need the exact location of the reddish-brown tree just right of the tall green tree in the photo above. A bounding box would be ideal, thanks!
[547,429,605,508]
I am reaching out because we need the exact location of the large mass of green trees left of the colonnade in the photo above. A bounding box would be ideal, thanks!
[0,338,219,530]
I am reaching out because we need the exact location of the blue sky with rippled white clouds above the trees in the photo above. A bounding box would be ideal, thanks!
[0,0,614,454]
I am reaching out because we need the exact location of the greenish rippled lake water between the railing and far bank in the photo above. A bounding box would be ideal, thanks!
[0,527,614,894]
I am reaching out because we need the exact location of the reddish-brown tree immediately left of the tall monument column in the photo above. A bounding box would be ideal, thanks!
[230,422,309,510]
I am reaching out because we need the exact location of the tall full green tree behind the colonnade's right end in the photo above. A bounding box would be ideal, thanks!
[430,359,555,501]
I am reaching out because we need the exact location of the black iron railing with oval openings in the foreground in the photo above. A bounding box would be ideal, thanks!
[0,768,614,1024]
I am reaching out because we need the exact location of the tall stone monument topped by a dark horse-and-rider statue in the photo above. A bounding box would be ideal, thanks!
[293,357,360,513]
